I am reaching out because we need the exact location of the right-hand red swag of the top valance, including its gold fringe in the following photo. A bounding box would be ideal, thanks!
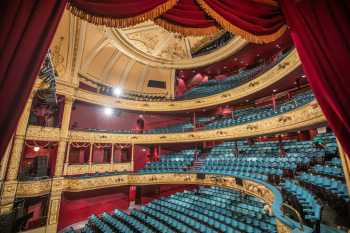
[196,0,286,43]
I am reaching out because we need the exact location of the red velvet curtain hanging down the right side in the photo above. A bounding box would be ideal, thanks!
[281,0,350,155]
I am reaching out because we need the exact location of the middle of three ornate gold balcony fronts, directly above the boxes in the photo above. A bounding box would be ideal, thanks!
[27,101,326,144]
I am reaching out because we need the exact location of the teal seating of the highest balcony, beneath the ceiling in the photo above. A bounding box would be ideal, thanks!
[176,52,289,100]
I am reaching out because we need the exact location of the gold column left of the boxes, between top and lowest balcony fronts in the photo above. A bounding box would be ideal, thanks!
[54,96,74,177]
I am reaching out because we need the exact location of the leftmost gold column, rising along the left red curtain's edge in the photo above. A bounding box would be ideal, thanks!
[0,95,34,214]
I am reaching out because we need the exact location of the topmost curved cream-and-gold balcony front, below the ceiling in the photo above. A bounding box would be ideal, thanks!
[57,49,301,112]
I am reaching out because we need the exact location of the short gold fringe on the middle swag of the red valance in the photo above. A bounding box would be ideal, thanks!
[153,18,220,36]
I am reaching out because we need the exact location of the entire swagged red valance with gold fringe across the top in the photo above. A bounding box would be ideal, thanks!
[68,0,286,43]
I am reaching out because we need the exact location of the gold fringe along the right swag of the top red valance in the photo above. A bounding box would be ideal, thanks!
[196,0,287,44]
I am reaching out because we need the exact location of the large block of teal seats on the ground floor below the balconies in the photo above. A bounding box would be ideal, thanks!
[81,187,277,233]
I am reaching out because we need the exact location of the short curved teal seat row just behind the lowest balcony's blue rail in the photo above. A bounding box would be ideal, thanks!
[282,180,321,223]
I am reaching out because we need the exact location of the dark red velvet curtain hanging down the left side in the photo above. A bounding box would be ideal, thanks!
[0,0,66,158]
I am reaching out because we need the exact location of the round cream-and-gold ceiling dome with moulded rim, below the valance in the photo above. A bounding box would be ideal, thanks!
[106,22,247,69]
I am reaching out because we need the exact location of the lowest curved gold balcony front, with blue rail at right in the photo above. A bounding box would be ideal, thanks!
[17,173,311,233]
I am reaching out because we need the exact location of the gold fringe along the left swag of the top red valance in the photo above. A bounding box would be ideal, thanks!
[67,0,177,28]
